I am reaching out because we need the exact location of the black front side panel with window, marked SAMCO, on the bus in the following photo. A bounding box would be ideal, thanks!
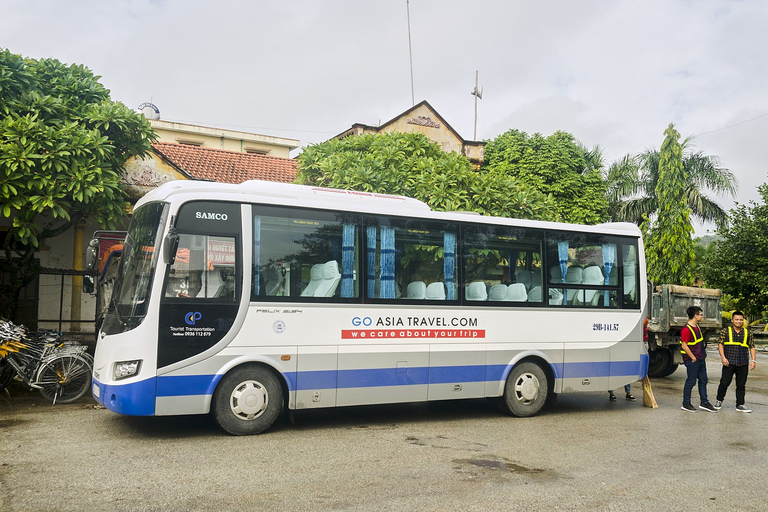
[157,201,243,372]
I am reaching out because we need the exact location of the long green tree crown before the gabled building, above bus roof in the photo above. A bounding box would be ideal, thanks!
[297,133,556,220]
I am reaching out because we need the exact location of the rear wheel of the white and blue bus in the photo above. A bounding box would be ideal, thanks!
[500,362,549,418]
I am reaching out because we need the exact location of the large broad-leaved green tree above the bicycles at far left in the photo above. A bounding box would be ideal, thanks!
[0,49,155,318]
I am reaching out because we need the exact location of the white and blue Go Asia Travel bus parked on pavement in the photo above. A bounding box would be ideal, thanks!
[93,181,648,434]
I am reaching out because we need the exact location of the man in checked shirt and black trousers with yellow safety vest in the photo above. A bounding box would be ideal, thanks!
[715,311,757,412]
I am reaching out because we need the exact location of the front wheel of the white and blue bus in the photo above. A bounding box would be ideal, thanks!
[211,366,283,436]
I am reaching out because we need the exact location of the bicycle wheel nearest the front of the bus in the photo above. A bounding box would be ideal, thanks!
[36,354,92,404]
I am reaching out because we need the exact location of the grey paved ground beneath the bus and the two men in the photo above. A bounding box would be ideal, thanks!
[0,352,768,512]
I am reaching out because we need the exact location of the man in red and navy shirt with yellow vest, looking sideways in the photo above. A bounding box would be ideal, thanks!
[680,306,717,412]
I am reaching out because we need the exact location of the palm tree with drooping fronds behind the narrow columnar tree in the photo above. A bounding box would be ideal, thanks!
[604,137,738,225]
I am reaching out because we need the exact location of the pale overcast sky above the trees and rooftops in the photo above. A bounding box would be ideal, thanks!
[0,0,768,234]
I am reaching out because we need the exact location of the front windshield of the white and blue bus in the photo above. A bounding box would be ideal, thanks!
[103,203,168,334]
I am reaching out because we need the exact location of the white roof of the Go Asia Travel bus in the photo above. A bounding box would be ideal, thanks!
[136,180,640,237]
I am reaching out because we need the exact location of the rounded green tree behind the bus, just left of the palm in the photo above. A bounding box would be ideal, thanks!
[483,130,608,224]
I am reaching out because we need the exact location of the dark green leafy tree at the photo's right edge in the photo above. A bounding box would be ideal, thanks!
[704,184,768,318]
